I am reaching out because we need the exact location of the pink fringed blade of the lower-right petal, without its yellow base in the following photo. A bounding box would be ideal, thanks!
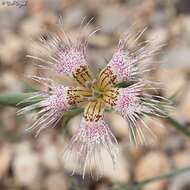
[113,82,171,144]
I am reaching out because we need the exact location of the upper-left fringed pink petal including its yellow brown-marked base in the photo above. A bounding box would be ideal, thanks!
[28,22,97,87]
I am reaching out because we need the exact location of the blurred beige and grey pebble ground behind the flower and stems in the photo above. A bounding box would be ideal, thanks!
[0,0,190,190]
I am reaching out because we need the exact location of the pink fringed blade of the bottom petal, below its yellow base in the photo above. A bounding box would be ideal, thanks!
[64,118,117,178]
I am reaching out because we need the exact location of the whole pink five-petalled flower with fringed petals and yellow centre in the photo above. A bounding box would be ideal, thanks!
[19,21,169,177]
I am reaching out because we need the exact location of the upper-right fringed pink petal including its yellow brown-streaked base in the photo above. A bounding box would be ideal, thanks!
[98,29,163,89]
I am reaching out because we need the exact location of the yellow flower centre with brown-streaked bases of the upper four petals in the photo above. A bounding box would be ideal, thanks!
[70,66,118,106]
